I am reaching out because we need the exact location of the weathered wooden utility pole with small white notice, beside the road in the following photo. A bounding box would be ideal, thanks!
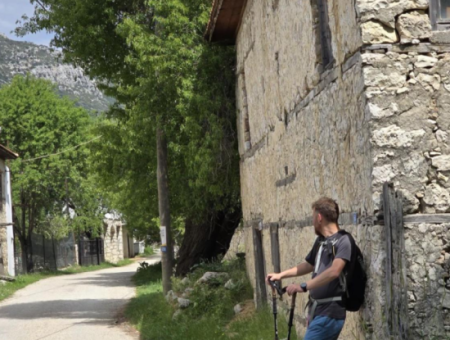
[156,123,174,295]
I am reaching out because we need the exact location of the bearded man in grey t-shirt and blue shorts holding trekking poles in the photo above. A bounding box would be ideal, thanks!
[267,197,352,340]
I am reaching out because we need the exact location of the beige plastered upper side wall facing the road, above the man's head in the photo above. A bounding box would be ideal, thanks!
[237,0,373,226]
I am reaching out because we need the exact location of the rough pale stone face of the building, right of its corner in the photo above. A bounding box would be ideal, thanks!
[357,0,450,339]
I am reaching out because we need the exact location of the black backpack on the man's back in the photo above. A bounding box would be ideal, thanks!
[339,230,367,312]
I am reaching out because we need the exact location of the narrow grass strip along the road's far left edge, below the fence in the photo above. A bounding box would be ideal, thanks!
[0,259,133,301]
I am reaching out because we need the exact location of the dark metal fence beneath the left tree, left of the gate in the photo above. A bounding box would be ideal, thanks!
[14,234,78,274]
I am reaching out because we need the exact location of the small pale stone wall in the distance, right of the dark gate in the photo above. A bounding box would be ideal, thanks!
[103,219,124,263]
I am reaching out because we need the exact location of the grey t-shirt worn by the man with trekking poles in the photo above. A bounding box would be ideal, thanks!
[306,233,352,321]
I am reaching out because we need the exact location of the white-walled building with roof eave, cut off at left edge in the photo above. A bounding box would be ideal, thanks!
[0,145,18,276]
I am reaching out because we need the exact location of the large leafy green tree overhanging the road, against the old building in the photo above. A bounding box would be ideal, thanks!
[22,0,241,275]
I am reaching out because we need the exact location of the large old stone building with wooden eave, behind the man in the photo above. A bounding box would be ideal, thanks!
[206,0,450,339]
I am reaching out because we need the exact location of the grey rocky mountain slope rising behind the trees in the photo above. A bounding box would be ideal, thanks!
[0,34,113,112]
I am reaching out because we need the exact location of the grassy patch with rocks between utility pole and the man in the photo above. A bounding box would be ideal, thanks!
[125,261,297,340]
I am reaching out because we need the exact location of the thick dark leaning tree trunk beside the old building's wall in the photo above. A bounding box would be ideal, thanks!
[176,209,242,276]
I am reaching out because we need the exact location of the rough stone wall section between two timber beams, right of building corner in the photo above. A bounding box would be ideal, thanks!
[362,49,450,213]
